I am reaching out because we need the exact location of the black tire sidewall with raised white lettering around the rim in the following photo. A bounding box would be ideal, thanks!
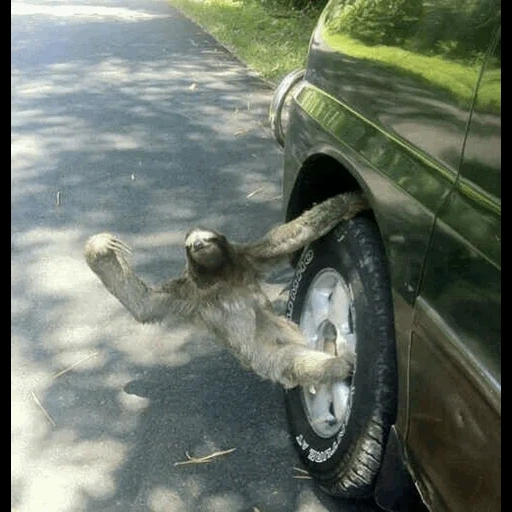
[286,218,394,480]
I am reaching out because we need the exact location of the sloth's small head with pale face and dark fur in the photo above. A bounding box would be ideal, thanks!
[185,228,231,274]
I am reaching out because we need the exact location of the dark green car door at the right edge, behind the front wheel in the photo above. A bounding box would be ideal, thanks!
[407,29,501,512]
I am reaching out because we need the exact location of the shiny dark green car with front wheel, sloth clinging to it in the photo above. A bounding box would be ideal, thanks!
[270,0,501,512]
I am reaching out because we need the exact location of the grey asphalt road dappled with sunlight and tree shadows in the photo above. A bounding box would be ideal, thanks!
[11,0,384,512]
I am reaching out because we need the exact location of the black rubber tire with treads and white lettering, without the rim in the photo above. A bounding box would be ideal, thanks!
[286,217,397,499]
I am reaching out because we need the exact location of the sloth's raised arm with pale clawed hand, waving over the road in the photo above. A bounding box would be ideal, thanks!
[84,233,190,323]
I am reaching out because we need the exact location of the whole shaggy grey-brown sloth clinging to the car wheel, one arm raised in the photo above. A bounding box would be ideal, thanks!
[84,192,368,389]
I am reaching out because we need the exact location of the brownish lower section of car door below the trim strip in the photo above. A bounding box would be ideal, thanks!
[405,300,501,512]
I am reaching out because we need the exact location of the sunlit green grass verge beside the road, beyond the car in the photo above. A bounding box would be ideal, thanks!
[169,0,320,82]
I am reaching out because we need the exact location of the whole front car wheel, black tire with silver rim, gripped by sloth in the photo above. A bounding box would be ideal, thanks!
[286,217,396,498]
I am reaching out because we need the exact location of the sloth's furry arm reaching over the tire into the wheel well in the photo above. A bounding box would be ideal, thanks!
[242,192,369,265]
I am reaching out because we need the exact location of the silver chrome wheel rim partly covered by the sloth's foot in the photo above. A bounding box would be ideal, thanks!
[299,268,357,438]
